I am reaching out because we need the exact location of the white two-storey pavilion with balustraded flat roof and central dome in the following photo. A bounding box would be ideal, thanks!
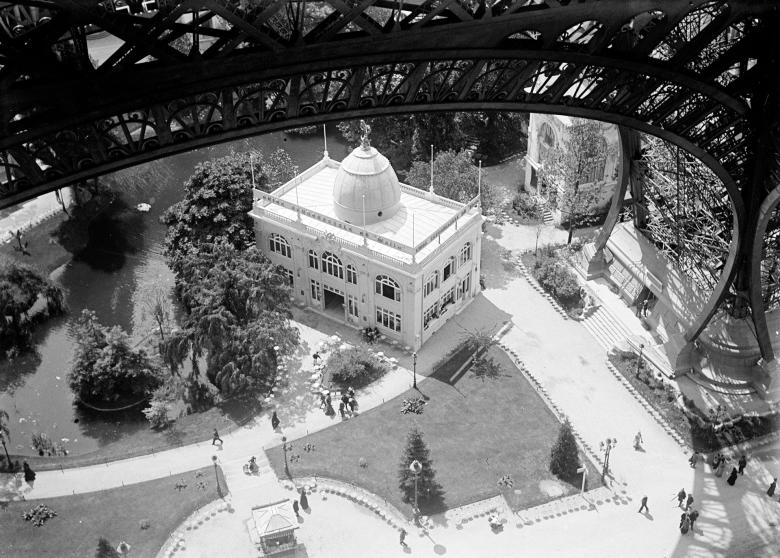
[250,140,482,350]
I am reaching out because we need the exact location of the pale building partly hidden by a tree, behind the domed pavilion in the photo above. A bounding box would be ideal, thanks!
[523,113,619,222]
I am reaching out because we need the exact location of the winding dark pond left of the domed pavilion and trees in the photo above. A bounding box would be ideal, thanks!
[0,127,346,455]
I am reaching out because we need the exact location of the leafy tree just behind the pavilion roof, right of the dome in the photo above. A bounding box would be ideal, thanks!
[406,151,500,210]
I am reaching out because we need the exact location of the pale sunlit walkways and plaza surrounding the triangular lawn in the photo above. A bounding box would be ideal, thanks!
[3,224,780,558]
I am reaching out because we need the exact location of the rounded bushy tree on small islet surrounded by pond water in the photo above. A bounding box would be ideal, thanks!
[68,310,162,402]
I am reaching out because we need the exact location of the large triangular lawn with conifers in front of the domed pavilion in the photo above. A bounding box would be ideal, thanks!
[267,347,598,514]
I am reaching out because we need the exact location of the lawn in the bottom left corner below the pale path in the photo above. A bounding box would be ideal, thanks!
[0,467,225,558]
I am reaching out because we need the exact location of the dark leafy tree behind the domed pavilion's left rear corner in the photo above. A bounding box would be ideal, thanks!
[161,149,298,264]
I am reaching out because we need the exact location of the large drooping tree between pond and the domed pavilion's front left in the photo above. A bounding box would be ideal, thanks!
[162,241,299,395]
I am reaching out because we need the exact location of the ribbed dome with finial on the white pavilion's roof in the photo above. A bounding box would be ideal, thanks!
[333,144,401,225]
